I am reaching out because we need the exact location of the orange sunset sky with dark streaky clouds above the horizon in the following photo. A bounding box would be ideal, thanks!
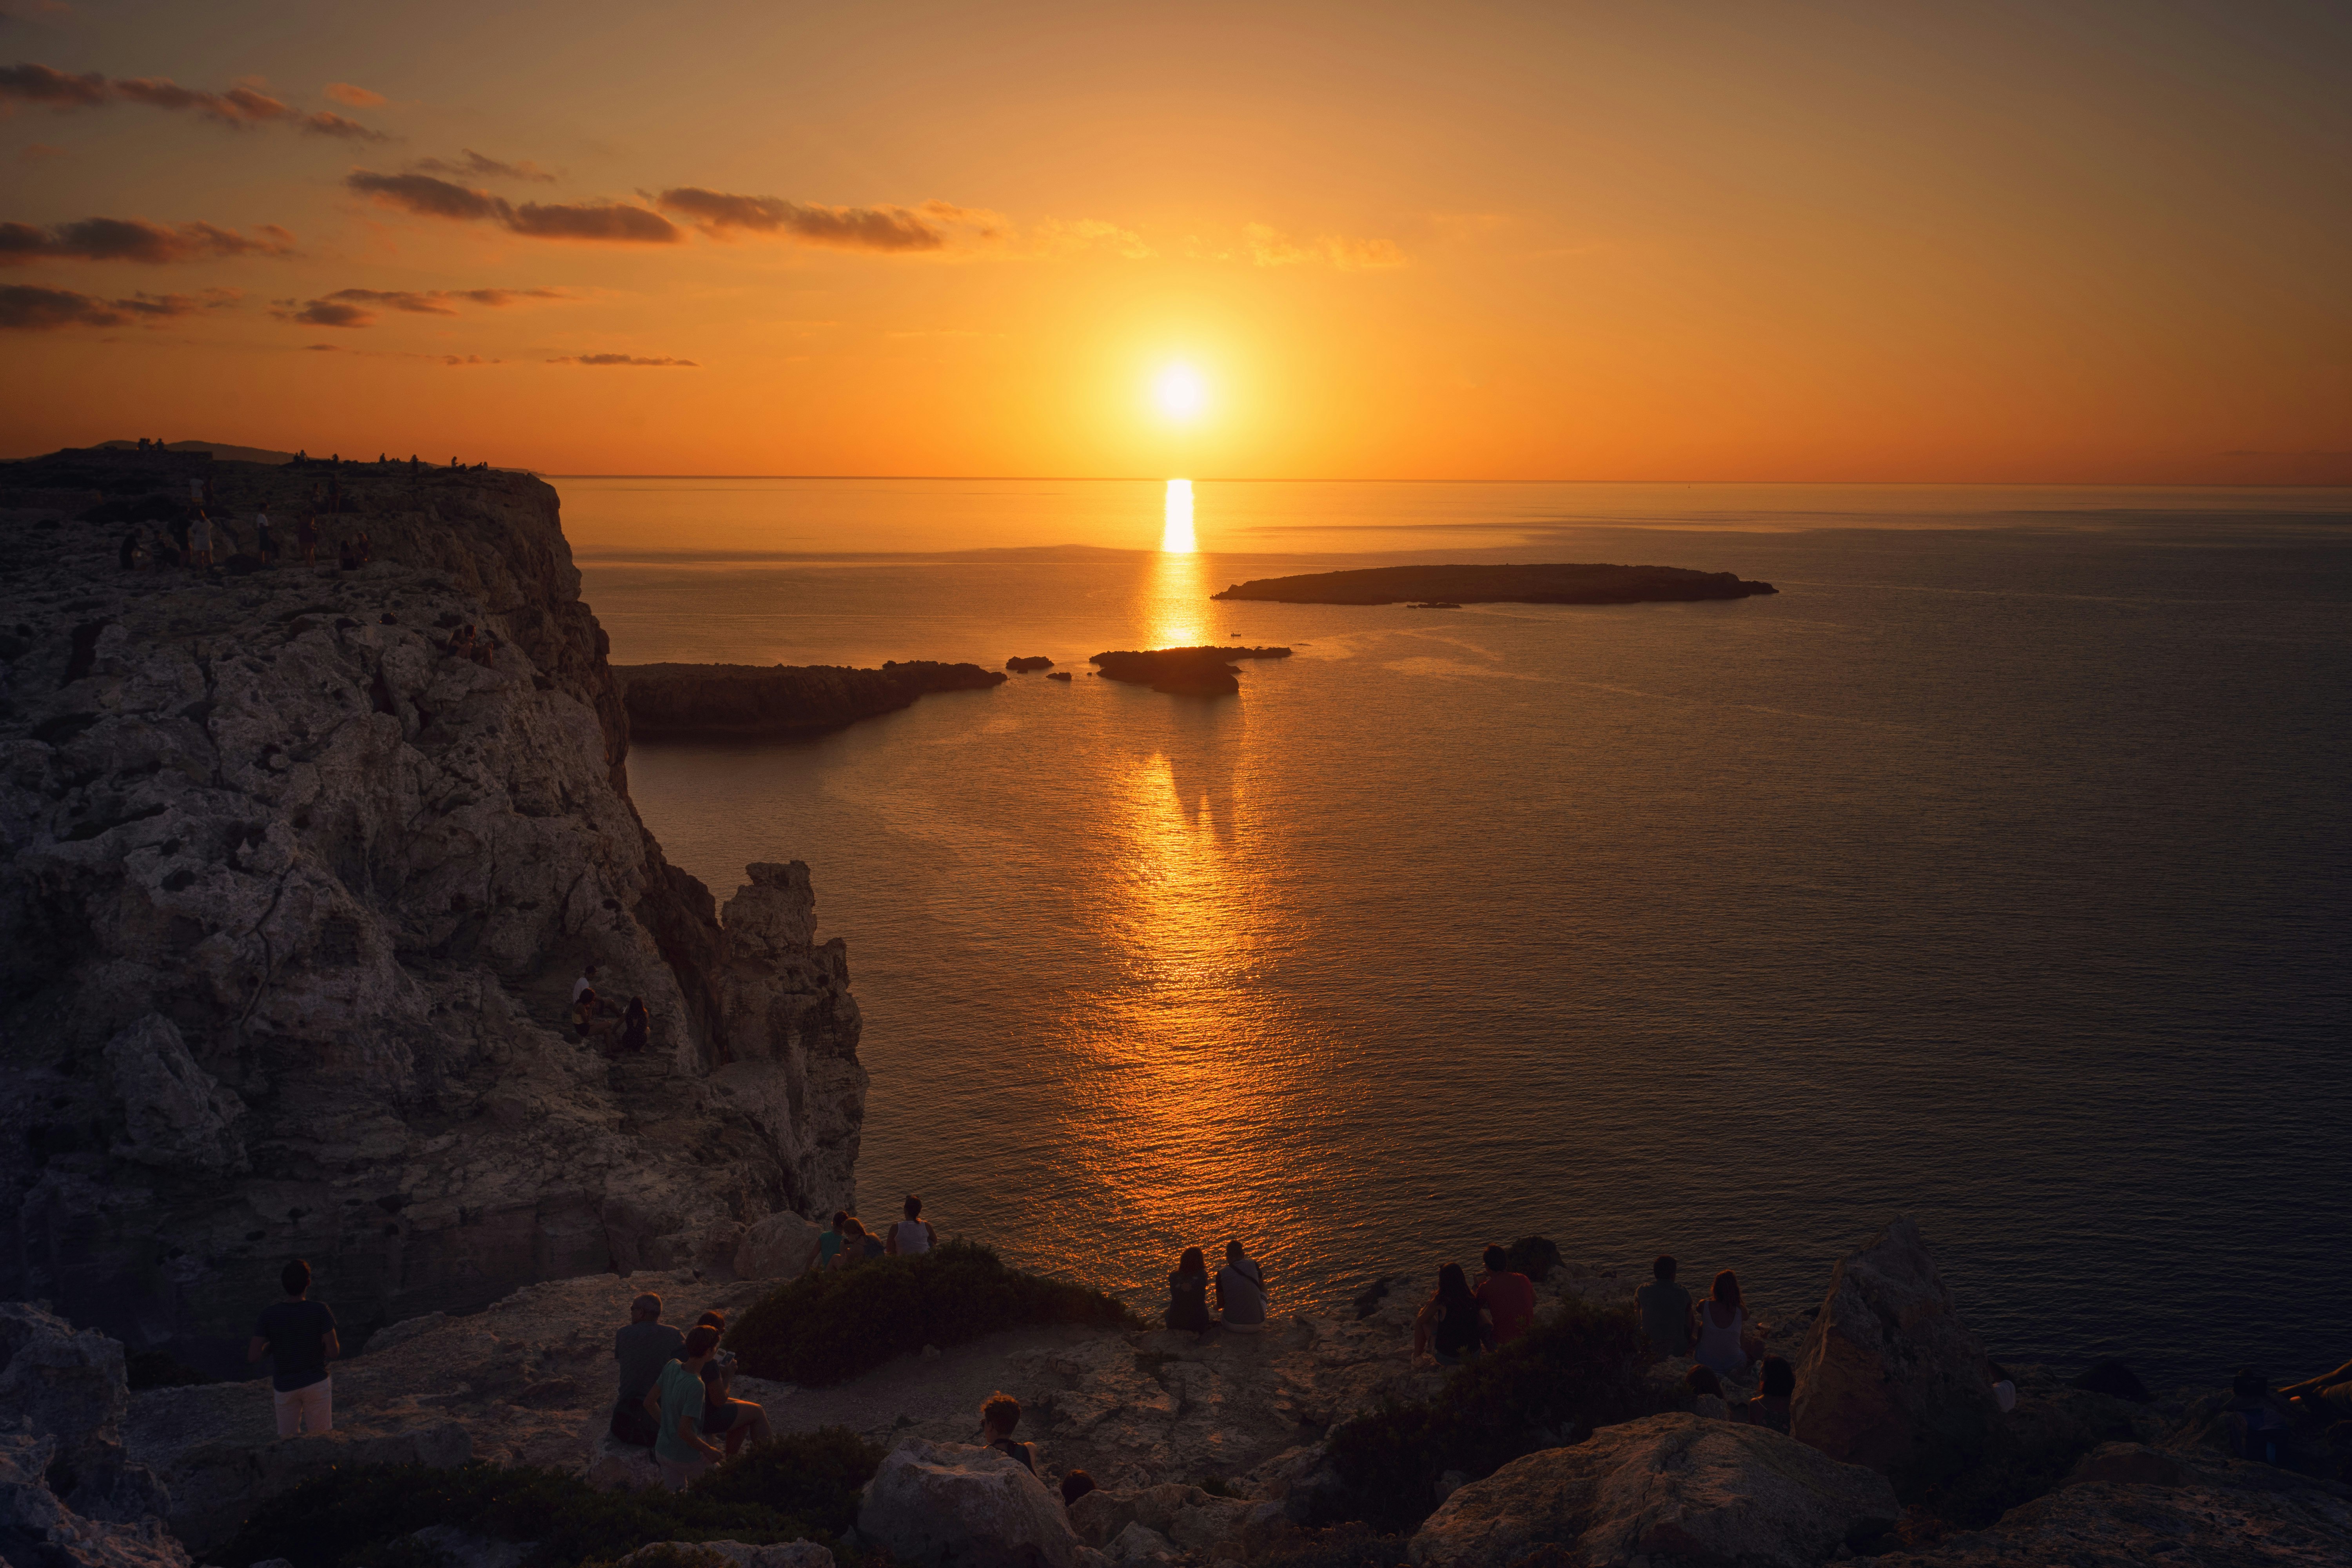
[0,0,2352,484]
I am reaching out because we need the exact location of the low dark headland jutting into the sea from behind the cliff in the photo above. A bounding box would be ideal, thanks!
[612,658,1007,740]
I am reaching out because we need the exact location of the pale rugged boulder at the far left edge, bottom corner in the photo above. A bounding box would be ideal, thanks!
[0,1302,172,1523]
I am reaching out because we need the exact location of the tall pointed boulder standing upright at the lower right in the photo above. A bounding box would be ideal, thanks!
[1790,1218,2002,1486]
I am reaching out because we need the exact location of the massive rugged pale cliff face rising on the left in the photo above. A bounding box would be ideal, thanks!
[0,454,866,1361]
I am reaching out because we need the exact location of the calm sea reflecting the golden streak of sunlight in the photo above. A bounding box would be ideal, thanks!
[553,477,2352,1387]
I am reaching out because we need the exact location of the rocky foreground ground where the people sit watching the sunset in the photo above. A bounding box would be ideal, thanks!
[0,1218,2352,1568]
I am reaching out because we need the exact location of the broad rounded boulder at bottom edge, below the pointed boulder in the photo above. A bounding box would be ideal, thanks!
[1411,1413,1900,1568]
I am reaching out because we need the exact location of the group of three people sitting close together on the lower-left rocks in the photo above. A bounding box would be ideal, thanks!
[609,1290,774,1493]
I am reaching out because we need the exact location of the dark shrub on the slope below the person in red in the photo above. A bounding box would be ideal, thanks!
[1324,1298,1665,1535]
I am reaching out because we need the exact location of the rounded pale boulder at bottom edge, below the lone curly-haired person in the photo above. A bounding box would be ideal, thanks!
[858,1441,1082,1568]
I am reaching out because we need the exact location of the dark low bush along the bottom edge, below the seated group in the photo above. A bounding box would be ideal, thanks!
[209,1427,882,1568]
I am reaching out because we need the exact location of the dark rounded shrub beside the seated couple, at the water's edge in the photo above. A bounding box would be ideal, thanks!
[727,1241,1134,1387]
